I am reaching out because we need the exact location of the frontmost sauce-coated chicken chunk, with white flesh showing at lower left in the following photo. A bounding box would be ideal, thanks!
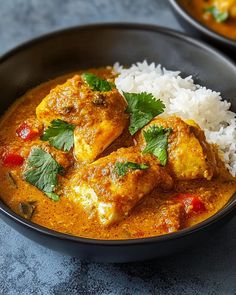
[65,147,173,226]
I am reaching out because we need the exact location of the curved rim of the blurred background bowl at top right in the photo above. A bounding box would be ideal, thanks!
[169,0,236,48]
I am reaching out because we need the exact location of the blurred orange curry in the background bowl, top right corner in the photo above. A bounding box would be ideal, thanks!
[179,0,236,40]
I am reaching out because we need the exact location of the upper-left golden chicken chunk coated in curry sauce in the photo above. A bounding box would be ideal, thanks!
[36,75,128,162]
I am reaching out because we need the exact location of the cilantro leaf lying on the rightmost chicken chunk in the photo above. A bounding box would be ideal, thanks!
[143,125,172,166]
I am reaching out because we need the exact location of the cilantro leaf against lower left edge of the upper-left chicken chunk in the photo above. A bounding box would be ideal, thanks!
[41,119,75,152]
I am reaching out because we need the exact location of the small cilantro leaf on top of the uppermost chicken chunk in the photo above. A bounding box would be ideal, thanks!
[81,73,115,92]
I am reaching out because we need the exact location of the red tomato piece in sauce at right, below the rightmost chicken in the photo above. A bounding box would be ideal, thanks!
[175,194,206,214]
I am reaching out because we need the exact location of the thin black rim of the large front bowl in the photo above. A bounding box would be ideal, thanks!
[0,23,236,246]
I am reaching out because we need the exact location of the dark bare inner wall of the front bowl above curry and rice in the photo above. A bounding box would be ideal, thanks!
[0,24,236,244]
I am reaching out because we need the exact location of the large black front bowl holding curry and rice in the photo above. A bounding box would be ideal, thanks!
[0,24,236,262]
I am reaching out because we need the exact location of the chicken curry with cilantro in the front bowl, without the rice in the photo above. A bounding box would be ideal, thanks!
[0,67,236,240]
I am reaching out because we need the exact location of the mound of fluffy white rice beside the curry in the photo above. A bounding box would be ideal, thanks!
[114,61,236,176]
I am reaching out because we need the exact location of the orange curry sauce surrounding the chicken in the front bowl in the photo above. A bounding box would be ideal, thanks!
[0,69,236,240]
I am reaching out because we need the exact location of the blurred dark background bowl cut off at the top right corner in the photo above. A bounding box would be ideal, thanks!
[169,0,236,59]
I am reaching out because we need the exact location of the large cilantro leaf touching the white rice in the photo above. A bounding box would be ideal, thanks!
[123,92,165,135]
